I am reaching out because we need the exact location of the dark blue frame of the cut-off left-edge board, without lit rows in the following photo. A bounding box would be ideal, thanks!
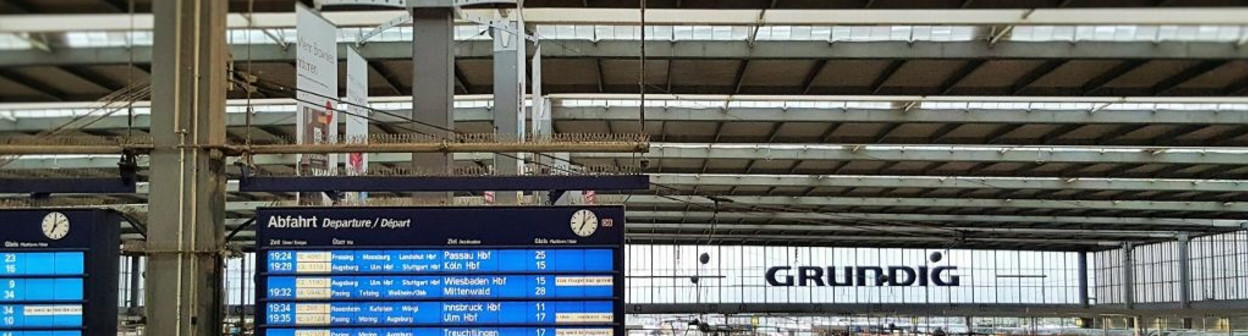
[0,209,121,336]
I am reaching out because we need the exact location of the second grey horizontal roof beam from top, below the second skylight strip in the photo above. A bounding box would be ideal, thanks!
[14,103,1248,133]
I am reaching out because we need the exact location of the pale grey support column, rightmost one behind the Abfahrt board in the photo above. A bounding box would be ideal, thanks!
[492,10,525,205]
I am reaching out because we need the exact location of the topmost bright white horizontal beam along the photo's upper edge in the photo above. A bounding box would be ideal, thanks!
[7,8,1248,32]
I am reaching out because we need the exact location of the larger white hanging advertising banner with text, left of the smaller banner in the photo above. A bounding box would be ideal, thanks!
[295,2,338,204]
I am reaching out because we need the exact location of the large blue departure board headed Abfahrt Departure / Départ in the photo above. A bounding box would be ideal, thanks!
[256,206,624,336]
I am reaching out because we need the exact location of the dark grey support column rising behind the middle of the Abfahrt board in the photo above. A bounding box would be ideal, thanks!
[408,5,456,204]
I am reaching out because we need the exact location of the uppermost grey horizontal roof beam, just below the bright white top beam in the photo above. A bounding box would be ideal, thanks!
[7,40,1248,67]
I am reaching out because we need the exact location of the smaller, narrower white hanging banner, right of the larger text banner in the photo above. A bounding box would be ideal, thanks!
[343,47,372,204]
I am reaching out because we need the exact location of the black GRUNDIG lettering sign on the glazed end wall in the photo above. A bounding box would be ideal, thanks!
[766,252,961,287]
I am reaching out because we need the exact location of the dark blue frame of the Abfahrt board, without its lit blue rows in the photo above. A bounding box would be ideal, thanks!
[256,206,625,336]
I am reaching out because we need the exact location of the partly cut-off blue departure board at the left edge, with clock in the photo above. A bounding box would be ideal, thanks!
[0,210,121,336]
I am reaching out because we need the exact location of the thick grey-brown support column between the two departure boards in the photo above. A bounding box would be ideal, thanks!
[146,0,228,336]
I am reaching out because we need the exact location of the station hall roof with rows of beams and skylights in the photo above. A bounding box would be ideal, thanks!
[0,0,1248,250]
